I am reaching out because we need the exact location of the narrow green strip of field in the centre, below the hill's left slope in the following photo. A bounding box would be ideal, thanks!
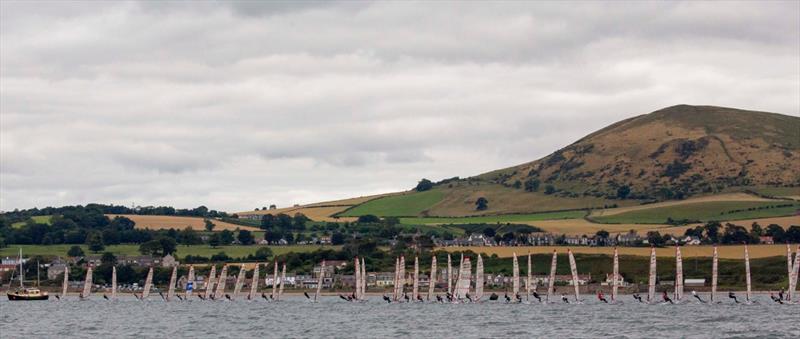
[400,211,586,225]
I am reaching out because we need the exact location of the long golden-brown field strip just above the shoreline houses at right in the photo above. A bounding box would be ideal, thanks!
[438,245,797,259]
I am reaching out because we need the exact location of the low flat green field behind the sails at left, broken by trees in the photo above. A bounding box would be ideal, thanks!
[0,245,341,258]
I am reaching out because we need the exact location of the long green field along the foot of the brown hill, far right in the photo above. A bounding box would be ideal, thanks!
[592,201,800,224]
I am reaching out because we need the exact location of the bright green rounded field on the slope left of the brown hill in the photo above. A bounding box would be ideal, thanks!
[339,190,444,217]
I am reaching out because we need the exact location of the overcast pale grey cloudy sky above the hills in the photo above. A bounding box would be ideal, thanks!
[0,0,800,212]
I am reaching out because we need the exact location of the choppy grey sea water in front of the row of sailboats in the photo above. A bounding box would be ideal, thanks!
[0,295,800,339]
